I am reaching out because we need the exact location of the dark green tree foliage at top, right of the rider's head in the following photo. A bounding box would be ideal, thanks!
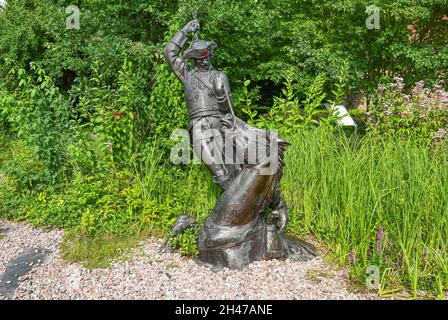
[178,0,448,92]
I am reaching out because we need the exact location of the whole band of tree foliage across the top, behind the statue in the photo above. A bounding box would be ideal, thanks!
[0,0,448,98]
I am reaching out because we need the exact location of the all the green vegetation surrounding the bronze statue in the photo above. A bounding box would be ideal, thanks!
[0,0,448,297]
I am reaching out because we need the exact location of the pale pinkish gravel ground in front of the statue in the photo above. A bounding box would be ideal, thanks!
[0,220,376,300]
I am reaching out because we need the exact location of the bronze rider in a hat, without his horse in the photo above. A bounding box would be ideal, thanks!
[164,20,232,189]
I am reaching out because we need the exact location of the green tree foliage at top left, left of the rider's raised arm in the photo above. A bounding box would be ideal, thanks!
[0,0,160,92]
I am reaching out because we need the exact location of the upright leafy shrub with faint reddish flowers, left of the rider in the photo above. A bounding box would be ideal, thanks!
[72,58,152,165]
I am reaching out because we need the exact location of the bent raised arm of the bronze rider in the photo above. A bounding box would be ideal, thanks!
[163,20,199,83]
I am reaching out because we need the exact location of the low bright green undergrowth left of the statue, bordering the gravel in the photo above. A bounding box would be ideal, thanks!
[0,136,220,244]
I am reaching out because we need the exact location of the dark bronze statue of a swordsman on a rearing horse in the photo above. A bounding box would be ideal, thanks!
[164,20,314,269]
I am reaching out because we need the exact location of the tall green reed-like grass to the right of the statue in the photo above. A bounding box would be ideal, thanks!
[283,128,448,297]
